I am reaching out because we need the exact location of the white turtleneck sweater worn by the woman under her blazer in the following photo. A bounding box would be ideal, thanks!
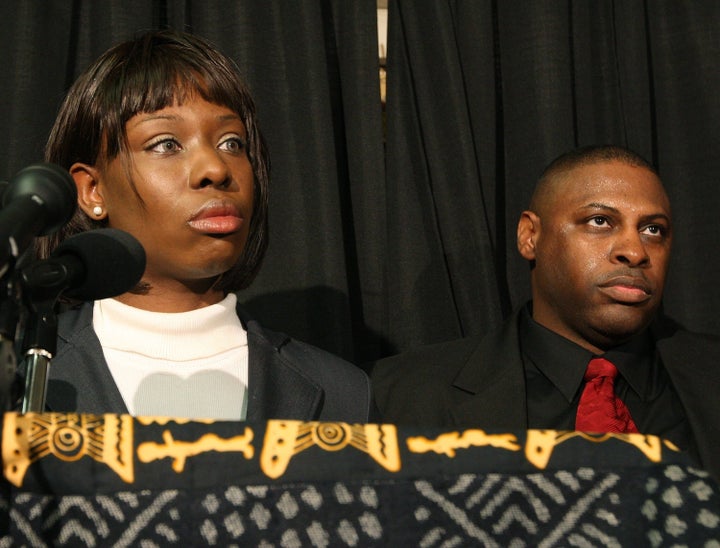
[93,294,248,420]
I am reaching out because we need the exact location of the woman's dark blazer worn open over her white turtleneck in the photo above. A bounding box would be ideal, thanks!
[41,303,377,423]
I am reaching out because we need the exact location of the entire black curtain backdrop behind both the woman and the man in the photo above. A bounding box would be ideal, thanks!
[0,0,720,363]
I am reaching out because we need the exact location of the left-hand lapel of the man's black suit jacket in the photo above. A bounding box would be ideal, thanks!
[450,314,527,429]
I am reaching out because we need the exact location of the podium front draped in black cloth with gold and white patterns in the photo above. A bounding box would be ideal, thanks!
[0,413,720,547]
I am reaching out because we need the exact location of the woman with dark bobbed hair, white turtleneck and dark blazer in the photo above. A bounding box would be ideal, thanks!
[38,31,374,422]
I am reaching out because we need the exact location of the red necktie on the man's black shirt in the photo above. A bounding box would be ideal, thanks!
[575,358,638,432]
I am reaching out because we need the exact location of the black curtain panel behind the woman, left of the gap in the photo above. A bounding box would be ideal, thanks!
[0,0,388,361]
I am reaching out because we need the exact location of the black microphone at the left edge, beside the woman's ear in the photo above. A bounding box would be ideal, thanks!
[0,163,77,276]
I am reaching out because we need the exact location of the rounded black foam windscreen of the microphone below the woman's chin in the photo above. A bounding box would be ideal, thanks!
[52,228,145,301]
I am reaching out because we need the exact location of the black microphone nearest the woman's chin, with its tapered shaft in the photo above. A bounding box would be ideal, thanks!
[21,228,145,301]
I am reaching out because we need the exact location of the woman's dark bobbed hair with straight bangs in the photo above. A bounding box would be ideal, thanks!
[36,30,270,292]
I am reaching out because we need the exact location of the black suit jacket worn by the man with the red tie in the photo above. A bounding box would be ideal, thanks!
[372,311,720,478]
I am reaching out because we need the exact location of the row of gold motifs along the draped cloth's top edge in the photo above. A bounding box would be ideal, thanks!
[2,413,678,487]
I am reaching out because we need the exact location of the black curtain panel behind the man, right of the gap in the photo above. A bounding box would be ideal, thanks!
[385,0,720,348]
